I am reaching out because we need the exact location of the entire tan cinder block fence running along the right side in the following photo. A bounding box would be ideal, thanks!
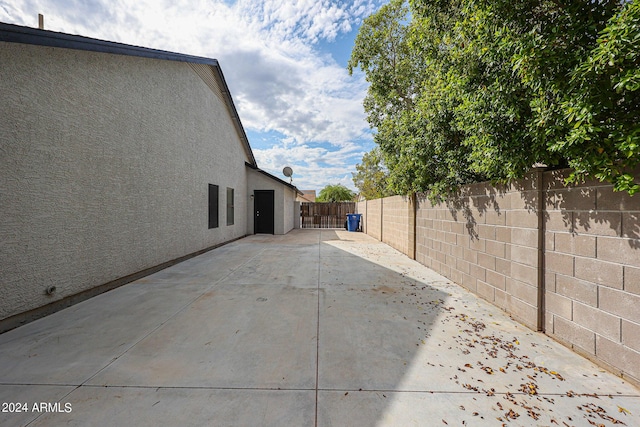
[357,170,640,384]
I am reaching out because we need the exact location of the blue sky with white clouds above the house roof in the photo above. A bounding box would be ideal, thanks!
[0,0,386,190]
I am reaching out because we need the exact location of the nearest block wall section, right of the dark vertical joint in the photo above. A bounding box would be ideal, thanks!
[544,171,640,382]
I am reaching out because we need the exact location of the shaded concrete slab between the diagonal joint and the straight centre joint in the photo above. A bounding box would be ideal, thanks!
[88,285,318,390]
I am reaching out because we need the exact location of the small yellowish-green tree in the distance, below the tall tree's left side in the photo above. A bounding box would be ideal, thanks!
[351,147,393,200]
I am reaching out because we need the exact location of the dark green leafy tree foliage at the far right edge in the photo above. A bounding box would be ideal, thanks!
[552,0,640,194]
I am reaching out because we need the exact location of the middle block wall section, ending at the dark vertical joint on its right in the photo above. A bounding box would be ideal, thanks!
[416,173,540,330]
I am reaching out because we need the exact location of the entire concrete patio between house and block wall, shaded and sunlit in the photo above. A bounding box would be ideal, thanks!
[0,230,640,426]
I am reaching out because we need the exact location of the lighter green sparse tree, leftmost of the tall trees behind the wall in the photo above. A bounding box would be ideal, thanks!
[348,1,480,194]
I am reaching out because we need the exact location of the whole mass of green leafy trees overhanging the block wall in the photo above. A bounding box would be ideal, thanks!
[348,0,640,195]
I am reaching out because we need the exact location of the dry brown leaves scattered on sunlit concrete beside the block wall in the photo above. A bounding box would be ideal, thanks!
[384,282,631,427]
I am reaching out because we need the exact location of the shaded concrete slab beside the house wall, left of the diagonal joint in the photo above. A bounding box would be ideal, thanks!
[0,280,207,385]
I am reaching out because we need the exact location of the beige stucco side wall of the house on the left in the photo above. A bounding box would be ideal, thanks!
[0,24,295,332]
